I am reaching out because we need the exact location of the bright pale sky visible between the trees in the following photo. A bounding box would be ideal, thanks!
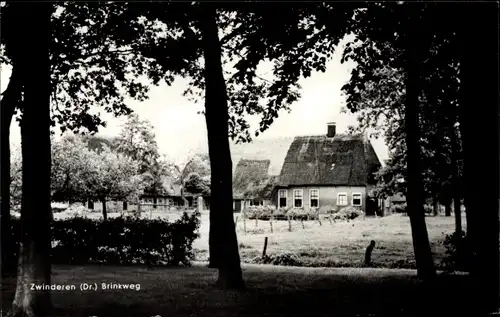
[0,35,388,162]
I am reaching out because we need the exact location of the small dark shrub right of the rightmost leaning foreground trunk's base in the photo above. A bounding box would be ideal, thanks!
[443,231,472,272]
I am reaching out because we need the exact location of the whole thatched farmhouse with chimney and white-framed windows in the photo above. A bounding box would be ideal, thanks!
[276,123,381,212]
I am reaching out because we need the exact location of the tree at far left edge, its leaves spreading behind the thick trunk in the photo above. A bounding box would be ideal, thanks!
[0,2,159,274]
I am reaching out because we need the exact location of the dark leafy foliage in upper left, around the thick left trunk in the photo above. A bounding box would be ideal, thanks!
[0,2,158,133]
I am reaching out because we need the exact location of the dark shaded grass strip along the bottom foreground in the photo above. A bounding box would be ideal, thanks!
[2,265,476,317]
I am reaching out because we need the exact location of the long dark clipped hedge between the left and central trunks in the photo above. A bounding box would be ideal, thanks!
[7,213,200,266]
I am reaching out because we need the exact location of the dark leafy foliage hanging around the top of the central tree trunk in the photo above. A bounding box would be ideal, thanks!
[101,2,356,142]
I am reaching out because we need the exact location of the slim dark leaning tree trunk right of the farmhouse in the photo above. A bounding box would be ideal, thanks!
[405,32,436,278]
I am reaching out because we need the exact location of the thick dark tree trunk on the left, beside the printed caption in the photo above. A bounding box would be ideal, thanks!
[10,3,53,316]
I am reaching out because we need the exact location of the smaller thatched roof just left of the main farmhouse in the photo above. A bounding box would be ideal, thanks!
[233,159,271,199]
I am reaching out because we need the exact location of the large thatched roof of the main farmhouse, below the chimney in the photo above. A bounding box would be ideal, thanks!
[279,135,381,186]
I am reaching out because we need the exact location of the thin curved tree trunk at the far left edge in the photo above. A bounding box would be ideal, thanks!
[0,63,21,276]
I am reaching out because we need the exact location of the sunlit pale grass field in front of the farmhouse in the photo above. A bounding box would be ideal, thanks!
[194,214,465,268]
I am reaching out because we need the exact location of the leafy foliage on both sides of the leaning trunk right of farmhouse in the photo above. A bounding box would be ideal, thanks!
[342,3,461,202]
